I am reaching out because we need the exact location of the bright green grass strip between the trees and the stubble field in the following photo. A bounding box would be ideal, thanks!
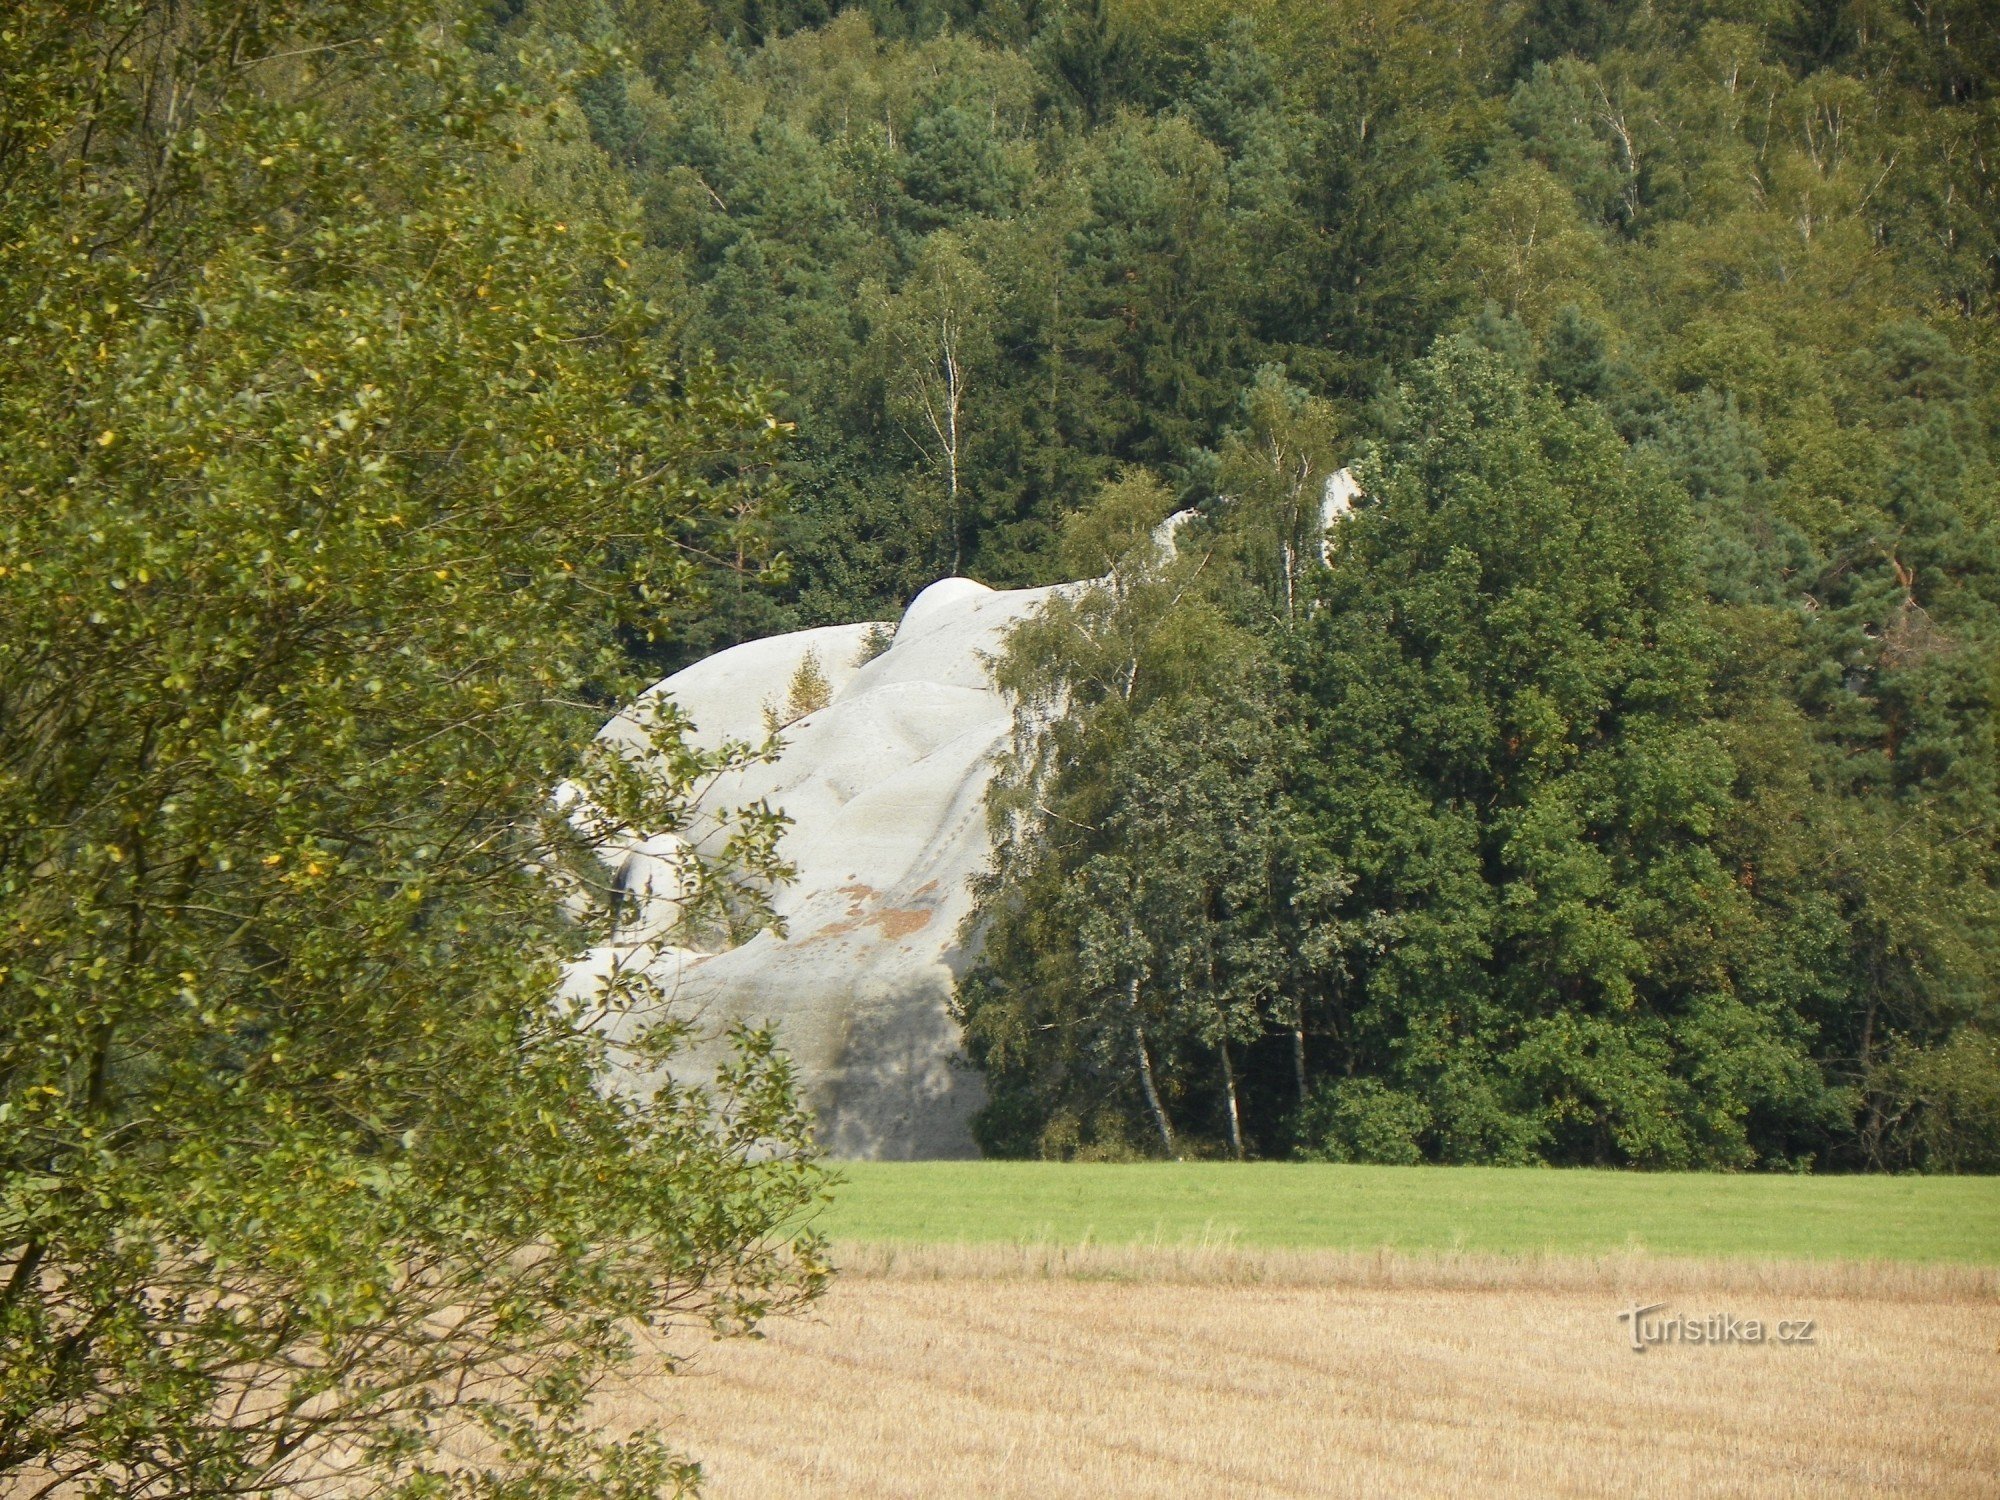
[822,1162,2000,1264]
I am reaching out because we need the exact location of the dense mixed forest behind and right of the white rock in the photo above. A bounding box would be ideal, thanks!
[486,0,2000,1170]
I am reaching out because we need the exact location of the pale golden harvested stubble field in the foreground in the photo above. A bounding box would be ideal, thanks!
[612,1244,2000,1500]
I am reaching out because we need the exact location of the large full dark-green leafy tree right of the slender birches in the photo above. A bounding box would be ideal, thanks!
[1302,346,1856,1166]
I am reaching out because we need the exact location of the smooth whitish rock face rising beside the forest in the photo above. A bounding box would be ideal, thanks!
[570,578,1052,1158]
